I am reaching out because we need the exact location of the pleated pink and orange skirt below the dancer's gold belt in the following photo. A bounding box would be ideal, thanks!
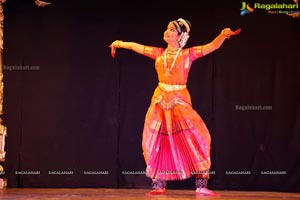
[142,87,211,181]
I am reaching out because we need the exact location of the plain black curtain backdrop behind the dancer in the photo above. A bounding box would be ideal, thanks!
[1,0,300,191]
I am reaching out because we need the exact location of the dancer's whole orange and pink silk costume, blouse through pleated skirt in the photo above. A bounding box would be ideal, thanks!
[142,46,211,181]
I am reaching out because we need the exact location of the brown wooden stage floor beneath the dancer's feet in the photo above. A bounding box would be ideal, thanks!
[0,188,300,200]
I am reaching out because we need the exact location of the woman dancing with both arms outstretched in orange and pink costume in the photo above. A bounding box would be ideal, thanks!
[109,18,241,196]
